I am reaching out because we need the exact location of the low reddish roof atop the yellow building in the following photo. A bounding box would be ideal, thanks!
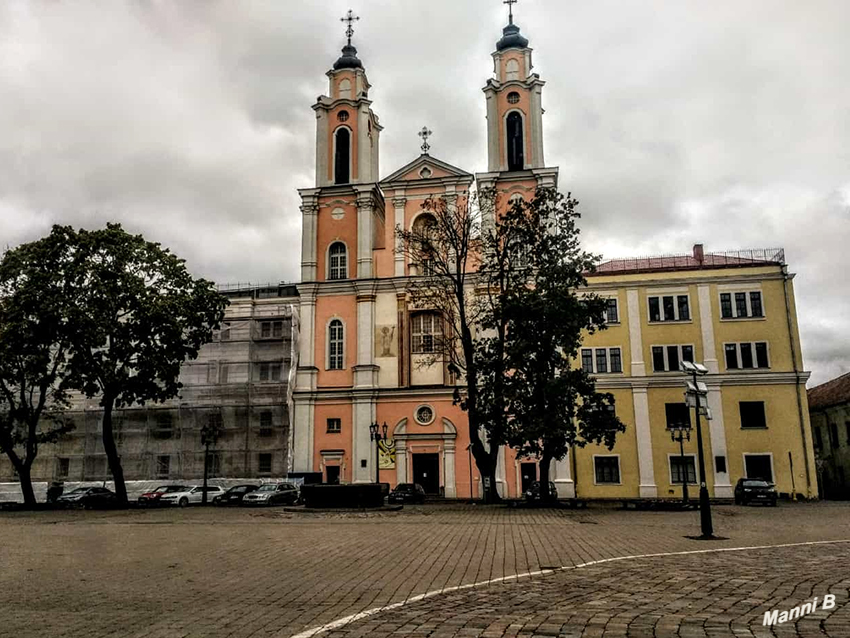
[593,244,785,275]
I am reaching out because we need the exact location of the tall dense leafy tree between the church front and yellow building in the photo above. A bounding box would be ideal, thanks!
[494,189,625,498]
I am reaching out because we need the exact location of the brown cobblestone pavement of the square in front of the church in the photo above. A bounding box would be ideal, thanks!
[0,503,850,638]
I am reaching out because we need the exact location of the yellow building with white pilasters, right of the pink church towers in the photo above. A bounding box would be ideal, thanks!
[576,245,817,498]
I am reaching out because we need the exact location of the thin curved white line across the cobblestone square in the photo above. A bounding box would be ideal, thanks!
[291,539,850,638]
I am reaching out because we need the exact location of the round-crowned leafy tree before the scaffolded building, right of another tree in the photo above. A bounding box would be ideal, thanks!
[68,224,228,503]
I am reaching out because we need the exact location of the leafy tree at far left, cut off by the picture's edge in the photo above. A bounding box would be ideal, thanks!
[0,226,77,507]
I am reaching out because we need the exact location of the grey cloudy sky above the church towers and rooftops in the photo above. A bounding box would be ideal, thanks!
[0,0,850,385]
